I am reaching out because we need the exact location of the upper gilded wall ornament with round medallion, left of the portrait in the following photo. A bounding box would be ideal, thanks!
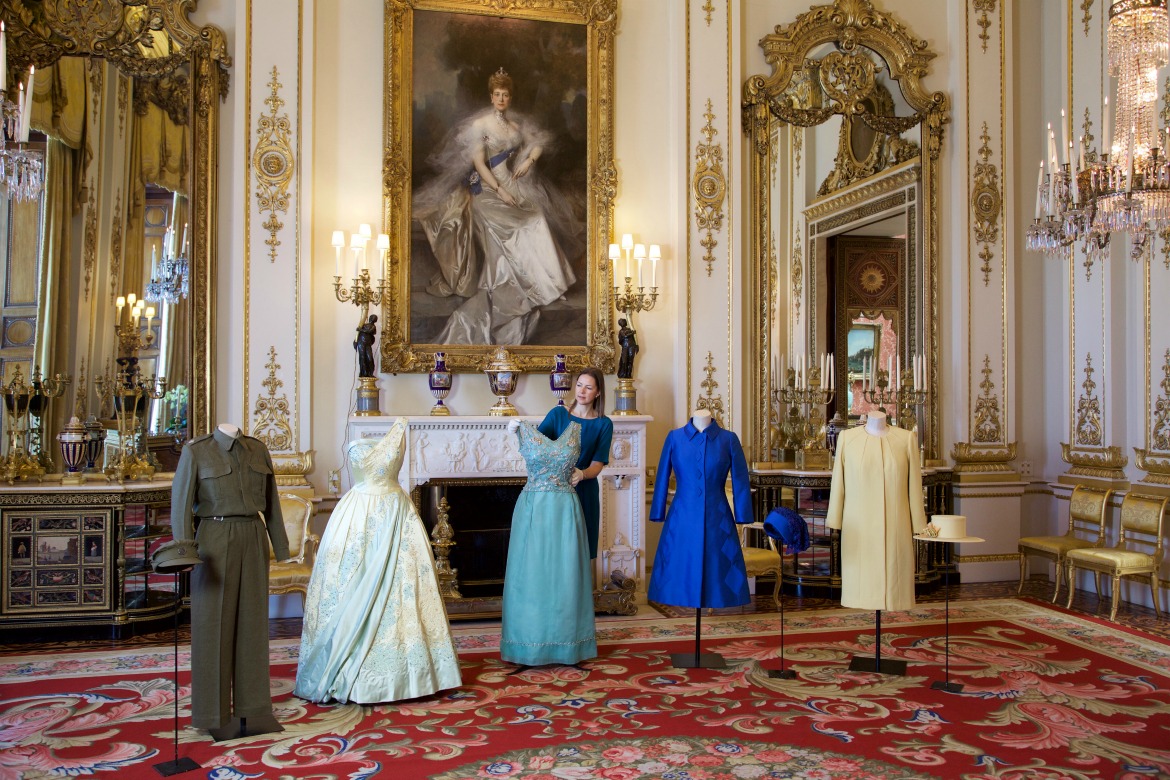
[252,65,296,263]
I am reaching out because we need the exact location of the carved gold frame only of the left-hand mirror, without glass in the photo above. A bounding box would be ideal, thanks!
[0,0,232,436]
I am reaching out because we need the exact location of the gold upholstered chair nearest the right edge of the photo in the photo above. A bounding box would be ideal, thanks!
[1065,492,1170,621]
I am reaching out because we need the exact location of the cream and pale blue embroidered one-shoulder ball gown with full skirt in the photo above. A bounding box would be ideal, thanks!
[294,417,462,704]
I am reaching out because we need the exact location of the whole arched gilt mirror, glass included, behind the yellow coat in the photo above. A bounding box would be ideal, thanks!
[743,0,948,461]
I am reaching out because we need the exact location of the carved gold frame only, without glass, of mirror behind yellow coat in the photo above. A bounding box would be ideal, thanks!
[742,0,949,460]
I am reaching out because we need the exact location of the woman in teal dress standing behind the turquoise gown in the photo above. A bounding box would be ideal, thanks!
[539,368,613,559]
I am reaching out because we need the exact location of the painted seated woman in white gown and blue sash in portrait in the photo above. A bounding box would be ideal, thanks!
[413,60,584,344]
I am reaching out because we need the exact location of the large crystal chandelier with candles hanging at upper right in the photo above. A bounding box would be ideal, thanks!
[1026,0,1170,263]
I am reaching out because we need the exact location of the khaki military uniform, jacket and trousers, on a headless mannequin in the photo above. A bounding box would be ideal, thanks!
[171,430,289,729]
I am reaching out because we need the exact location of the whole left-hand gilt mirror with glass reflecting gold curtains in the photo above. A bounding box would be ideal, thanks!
[0,0,230,465]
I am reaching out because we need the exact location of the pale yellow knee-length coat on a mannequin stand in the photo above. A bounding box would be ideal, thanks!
[825,427,927,610]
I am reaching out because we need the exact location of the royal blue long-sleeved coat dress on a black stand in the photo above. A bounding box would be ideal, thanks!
[648,420,752,607]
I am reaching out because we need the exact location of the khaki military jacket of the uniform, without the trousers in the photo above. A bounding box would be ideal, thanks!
[171,430,289,560]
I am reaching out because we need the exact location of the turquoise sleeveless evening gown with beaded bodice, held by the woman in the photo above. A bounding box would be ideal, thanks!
[500,421,597,667]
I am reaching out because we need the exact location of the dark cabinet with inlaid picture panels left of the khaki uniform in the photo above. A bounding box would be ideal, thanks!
[0,481,185,637]
